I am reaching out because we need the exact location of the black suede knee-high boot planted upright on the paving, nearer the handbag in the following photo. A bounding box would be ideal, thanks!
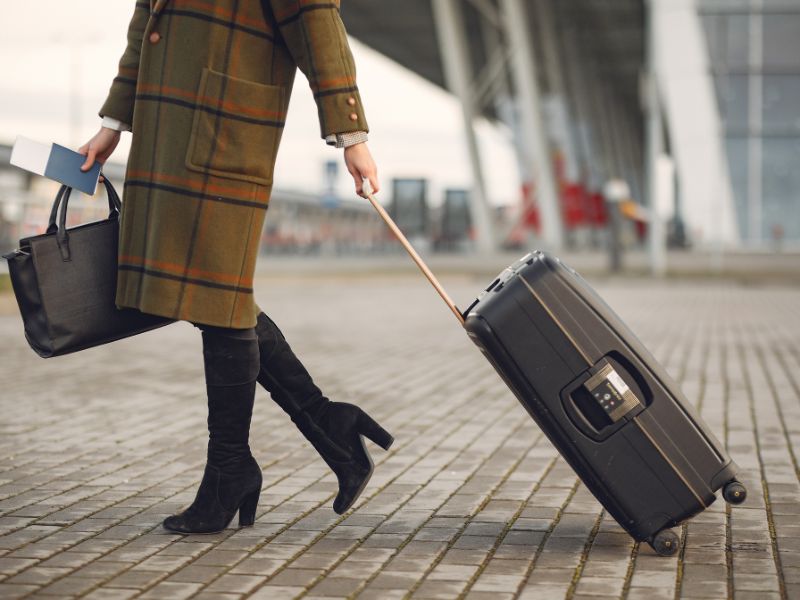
[163,324,261,533]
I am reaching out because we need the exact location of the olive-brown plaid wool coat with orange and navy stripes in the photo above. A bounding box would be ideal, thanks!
[98,0,368,328]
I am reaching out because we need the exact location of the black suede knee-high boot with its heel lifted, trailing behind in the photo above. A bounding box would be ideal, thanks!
[256,312,394,514]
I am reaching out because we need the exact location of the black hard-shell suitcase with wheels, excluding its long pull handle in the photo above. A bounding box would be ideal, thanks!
[465,252,746,555]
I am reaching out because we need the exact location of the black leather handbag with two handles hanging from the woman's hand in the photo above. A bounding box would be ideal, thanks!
[3,178,175,358]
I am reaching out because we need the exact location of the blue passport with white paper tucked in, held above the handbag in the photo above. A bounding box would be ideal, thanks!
[10,136,102,196]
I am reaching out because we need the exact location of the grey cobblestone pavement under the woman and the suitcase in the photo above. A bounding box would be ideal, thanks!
[0,275,800,600]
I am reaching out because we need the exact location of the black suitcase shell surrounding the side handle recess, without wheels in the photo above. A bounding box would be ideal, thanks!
[466,253,735,540]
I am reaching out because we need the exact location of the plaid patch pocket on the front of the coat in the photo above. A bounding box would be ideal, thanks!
[186,67,286,185]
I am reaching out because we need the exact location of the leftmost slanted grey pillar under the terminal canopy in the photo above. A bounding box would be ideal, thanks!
[432,0,495,252]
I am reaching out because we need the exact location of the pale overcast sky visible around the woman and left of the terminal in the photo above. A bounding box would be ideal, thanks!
[0,0,518,203]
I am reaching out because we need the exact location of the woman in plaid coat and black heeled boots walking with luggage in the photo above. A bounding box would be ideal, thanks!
[79,0,393,533]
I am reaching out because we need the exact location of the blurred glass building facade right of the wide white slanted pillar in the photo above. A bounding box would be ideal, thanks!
[698,0,800,246]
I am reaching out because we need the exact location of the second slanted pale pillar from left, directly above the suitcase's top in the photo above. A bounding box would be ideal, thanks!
[500,0,564,251]
